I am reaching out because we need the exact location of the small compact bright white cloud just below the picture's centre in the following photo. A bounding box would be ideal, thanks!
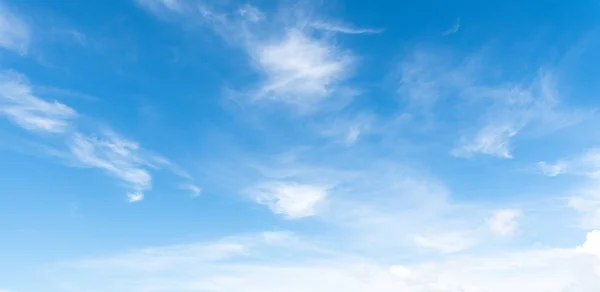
[249,182,328,219]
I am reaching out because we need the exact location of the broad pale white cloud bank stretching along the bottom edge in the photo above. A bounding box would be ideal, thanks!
[47,231,600,292]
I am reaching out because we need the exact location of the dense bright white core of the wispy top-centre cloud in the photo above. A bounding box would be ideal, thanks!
[250,28,353,109]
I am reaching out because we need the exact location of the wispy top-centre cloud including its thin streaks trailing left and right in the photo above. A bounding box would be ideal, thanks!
[138,0,376,112]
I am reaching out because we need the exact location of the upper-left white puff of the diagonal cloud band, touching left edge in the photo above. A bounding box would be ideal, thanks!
[0,71,77,133]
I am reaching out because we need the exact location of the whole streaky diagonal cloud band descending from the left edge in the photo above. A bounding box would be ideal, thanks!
[0,71,197,203]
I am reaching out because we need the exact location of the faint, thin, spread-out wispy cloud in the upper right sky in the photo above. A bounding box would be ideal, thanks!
[398,49,587,159]
